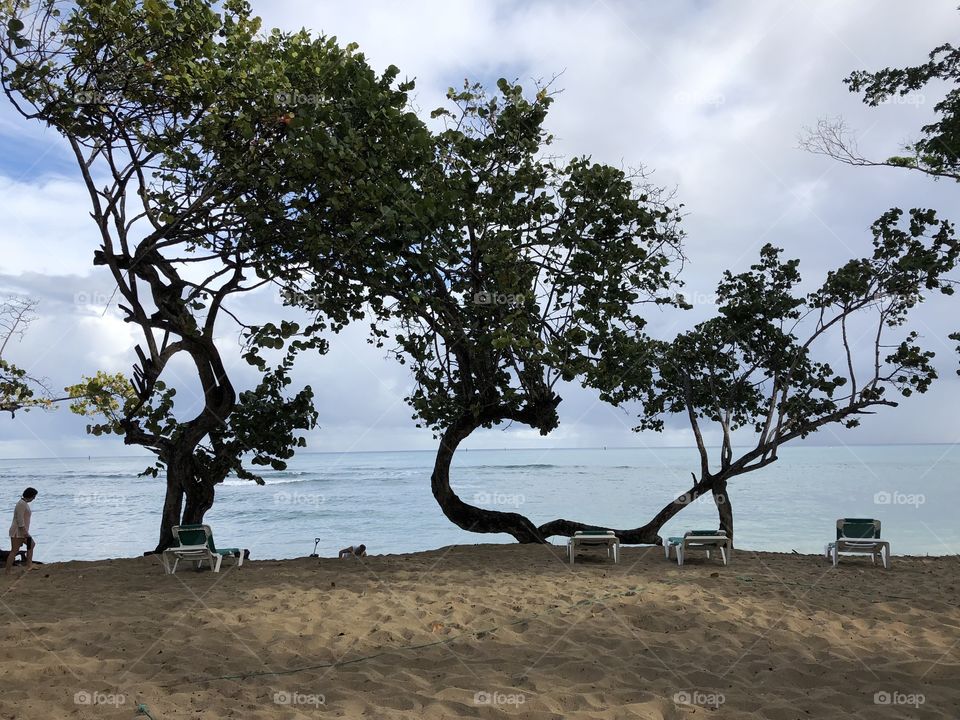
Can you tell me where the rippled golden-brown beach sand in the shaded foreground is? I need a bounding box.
[0,545,960,720]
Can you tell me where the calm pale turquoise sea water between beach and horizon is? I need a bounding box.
[0,445,960,561]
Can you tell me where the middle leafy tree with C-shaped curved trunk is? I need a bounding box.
[274,80,680,542]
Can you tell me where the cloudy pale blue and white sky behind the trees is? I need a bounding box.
[0,0,960,458]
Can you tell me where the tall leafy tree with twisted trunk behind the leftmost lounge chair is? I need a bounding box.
[0,0,428,550]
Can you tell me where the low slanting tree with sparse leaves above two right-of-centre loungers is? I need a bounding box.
[567,210,960,542]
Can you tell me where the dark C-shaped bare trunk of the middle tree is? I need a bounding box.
[430,419,546,543]
